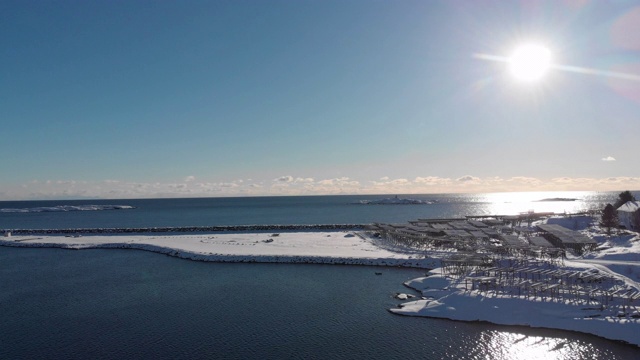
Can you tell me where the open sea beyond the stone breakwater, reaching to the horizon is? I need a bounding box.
[0,192,617,229]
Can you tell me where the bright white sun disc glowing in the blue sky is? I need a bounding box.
[508,44,551,82]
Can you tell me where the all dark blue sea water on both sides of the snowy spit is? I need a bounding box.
[0,193,640,359]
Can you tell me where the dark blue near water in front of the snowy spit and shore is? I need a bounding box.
[0,247,640,359]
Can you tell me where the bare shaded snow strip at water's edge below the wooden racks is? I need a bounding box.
[389,270,640,346]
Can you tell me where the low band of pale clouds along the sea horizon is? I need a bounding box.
[0,175,640,200]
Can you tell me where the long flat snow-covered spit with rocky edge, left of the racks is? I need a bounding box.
[0,232,433,268]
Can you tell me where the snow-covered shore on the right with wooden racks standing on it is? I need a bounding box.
[390,217,640,346]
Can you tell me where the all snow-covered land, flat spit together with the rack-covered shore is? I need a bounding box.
[0,217,640,346]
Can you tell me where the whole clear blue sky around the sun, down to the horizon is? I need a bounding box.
[0,0,640,200]
